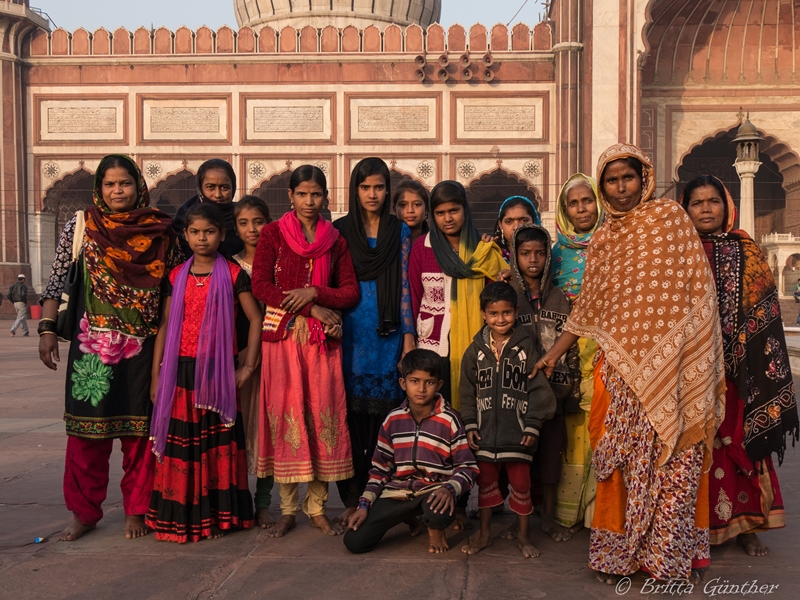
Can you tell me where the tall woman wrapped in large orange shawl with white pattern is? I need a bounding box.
[536,144,725,583]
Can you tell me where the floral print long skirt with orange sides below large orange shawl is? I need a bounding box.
[589,358,710,580]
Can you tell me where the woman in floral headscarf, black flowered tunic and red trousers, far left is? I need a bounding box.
[39,155,182,541]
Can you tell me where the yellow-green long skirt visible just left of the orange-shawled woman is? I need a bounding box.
[556,338,597,527]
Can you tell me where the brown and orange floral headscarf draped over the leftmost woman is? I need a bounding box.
[79,154,180,364]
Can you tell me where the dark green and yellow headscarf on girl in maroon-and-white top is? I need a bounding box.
[428,181,508,410]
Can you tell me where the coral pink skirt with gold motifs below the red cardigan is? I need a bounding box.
[257,335,354,483]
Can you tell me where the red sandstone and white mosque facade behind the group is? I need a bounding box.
[0,0,800,300]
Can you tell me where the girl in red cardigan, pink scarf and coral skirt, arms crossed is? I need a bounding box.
[253,165,359,537]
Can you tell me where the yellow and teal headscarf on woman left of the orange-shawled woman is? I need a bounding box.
[553,173,604,302]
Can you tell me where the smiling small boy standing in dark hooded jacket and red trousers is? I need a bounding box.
[460,281,556,558]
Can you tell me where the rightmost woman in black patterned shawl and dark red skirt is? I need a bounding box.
[681,175,798,556]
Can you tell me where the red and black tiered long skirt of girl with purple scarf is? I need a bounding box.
[146,359,254,543]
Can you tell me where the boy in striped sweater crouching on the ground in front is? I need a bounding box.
[344,350,478,554]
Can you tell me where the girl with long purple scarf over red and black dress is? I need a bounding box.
[146,204,261,543]
